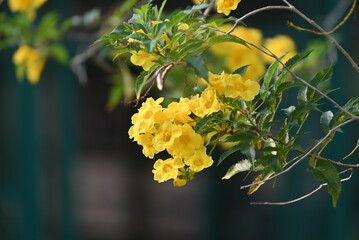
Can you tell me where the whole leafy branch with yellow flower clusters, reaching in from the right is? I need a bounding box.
[98,0,359,206]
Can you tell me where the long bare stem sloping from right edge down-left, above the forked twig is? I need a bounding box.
[240,118,354,189]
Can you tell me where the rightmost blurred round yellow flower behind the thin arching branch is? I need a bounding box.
[264,35,297,64]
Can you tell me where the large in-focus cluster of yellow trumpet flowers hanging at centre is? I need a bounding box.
[129,92,220,186]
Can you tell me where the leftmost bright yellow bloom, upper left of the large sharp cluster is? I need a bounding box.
[128,98,163,141]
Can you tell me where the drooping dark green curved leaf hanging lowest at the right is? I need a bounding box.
[309,160,342,207]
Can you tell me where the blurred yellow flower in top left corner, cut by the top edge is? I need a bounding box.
[8,0,47,20]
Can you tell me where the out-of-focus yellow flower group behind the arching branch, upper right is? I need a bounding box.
[211,24,296,81]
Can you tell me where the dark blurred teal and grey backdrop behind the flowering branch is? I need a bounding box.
[0,0,359,240]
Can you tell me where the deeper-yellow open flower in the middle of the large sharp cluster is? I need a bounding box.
[169,124,204,157]
